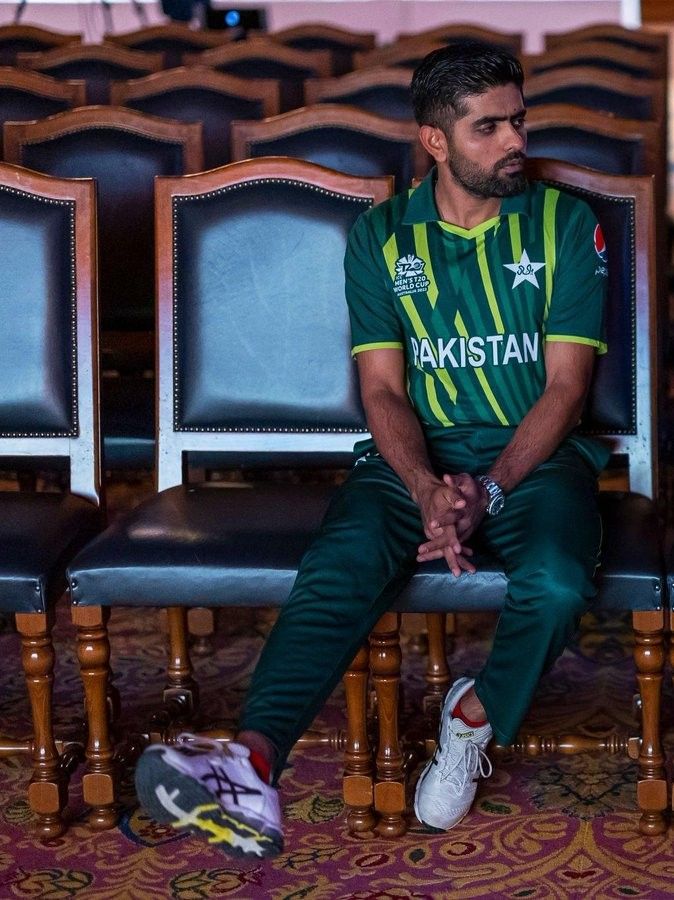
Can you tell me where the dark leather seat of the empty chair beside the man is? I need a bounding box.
[68,483,335,606]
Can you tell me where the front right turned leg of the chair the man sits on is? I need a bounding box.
[632,610,667,835]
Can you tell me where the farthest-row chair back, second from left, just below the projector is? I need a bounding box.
[103,22,240,69]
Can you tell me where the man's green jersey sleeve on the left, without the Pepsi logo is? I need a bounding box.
[344,213,404,355]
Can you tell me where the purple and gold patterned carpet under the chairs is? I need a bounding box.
[0,588,674,900]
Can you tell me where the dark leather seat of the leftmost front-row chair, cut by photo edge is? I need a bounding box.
[0,491,100,612]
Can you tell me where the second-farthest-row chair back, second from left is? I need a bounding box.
[183,38,332,112]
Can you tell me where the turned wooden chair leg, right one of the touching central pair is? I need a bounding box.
[370,613,407,837]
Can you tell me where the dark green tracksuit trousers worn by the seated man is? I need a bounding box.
[240,428,601,779]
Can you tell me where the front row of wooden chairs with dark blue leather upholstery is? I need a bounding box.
[0,158,668,836]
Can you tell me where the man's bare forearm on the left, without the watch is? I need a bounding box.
[366,390,439,503]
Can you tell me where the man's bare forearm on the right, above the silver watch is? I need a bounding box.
[489,384,584,493]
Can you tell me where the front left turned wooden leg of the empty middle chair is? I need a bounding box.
[72,606,118,830]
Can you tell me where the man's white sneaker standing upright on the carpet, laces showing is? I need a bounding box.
[414,678,492,831]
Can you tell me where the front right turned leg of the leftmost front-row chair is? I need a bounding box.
[16,612,68,838]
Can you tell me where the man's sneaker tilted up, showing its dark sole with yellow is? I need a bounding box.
[136,734,283,857]
